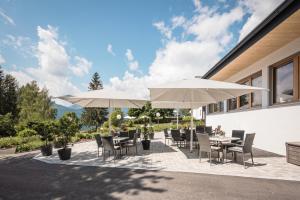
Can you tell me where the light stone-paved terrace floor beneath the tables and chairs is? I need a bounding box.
[34,133,300,181]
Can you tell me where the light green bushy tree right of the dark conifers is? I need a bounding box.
[18,81,56,122]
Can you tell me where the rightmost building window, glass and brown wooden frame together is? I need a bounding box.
[270,53,300,104]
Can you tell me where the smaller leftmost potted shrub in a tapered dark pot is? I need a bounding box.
[38,121,57,156]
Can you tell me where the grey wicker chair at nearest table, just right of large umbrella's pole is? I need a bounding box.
[197,133,221,164]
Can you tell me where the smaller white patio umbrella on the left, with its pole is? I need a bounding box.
[58,89,148,133]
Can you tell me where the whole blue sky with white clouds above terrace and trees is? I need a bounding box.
[0,0,283,105]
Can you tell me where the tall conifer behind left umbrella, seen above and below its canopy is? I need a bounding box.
[81,72,108,130]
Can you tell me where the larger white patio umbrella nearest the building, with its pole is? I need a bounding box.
[149,78,266,151]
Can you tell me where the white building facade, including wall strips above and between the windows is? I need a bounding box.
[206,38,300,155]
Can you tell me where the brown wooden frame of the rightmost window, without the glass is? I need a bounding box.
[269,52,300,106]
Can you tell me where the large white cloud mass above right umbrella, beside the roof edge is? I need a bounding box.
[106,1,244,97]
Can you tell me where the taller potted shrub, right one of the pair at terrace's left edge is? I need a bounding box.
[57,112,80,160]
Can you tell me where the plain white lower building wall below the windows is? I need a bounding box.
[206,105,300,155]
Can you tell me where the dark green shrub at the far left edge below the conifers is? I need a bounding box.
[0,113,16,137]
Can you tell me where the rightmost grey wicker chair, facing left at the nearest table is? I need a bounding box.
[228,133,255,168]
